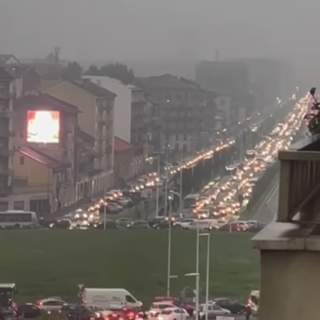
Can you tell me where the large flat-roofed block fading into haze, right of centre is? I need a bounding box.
[196,61,255,135]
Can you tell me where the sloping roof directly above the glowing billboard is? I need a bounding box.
[13,94,80,114]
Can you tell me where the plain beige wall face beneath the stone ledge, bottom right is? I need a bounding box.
[259,250,320,320]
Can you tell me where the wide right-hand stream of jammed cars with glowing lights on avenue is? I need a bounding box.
[174,95,307,232]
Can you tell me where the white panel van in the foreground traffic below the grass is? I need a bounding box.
[82,288,142,309]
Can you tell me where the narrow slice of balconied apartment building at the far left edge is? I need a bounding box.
[0,67,14,204]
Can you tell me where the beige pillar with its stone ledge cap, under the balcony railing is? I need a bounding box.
[252,222,320,320]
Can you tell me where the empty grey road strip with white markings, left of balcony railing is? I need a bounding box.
[252,181,279,225]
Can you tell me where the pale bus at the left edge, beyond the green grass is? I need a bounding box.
[0,210,39,228]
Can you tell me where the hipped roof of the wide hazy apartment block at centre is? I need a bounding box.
[137,74,200,90]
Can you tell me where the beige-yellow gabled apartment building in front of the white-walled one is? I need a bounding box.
[42,79,116,195]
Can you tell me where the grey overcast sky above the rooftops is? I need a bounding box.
[0,0,320,83]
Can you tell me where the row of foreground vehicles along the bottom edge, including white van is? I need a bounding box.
[0,283,255,320]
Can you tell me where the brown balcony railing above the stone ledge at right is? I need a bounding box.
[277,137,320,223]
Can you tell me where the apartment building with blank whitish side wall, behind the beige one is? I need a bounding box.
[83,76,152,175]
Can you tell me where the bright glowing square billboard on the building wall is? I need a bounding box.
[27,110,60,143]
